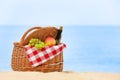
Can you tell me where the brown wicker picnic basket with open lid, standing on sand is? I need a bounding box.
[11,27,63,72]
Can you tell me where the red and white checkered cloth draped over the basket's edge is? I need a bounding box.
[24,43,66,67]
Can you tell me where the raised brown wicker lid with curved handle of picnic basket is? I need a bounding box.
[20,26,63,46]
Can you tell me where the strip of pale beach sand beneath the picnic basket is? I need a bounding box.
[0,71,120,80]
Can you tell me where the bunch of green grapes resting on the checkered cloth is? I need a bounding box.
[28,38,47,49]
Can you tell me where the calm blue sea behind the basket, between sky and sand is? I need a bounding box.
[0,25,120,73]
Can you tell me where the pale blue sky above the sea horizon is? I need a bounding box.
[0,0,120,26]
